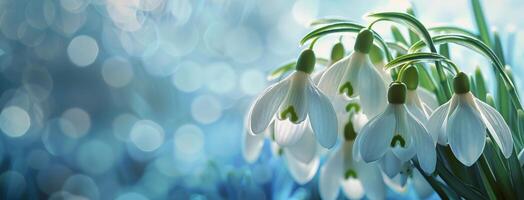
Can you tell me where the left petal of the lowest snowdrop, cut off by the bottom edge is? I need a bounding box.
[318,148,344,200]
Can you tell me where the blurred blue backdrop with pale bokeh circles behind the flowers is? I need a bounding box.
[0,0,524,200]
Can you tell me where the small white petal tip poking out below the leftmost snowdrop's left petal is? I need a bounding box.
[242,132,264,163]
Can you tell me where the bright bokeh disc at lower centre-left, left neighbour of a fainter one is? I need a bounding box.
[129,120,164,152]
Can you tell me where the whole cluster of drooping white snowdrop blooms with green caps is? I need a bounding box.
[239,7,524,199]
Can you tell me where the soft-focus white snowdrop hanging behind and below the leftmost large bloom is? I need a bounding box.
[242,120,320,184]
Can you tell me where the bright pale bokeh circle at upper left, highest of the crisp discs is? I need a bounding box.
[67,35,99,67]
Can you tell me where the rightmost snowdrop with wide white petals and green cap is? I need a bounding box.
[427,72,513,166]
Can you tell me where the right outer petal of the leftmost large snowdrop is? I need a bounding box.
[308,85,338,149]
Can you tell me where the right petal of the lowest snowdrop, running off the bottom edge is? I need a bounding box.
[355,162,386,199]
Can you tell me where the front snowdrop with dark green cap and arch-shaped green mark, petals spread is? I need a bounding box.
[353,82,436,177]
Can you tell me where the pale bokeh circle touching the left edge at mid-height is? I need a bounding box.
[0,106,31,137]
